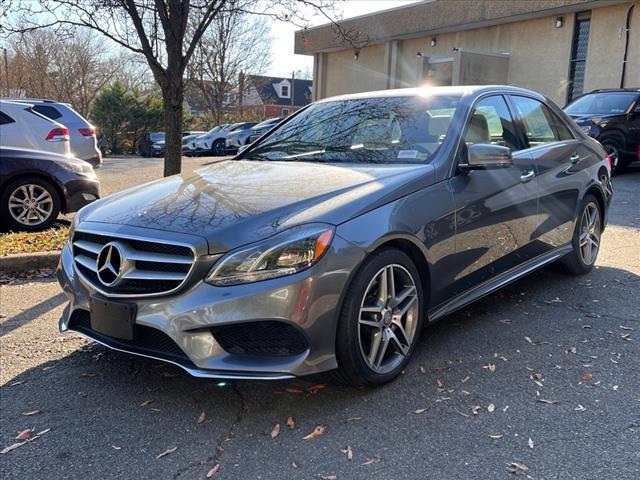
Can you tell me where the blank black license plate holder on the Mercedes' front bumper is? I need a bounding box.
[89,297,136,340]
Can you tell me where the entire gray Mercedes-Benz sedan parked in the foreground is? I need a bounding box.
[58,86,612,385]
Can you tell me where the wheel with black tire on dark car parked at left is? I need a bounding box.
[0,178,60,232]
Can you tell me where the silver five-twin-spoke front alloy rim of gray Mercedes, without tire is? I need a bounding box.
[358,264,419,374]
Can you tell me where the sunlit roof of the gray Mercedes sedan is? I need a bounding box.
[318,85,542,102]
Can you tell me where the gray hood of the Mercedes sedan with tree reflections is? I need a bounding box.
[79,160,435,253]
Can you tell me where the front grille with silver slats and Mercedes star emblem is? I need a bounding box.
[73,230,195,296]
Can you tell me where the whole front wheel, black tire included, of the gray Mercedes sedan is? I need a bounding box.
[336,249,424,387]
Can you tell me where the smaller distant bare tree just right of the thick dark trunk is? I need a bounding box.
[188,7,271,123]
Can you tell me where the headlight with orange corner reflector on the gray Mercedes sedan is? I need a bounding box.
[205,224,334,287]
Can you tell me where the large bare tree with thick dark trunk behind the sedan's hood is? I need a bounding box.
[2,0,350,175]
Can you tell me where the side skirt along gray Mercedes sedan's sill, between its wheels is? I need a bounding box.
[428,244,573,322]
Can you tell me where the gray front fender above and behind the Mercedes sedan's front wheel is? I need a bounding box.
[337,181,456,304]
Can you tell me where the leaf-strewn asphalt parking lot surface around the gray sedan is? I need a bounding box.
[0,162,640,479]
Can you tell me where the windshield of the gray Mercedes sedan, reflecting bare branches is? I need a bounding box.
[247,95,460,163]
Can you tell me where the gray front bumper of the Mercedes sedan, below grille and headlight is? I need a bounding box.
[57,231,364,379]
